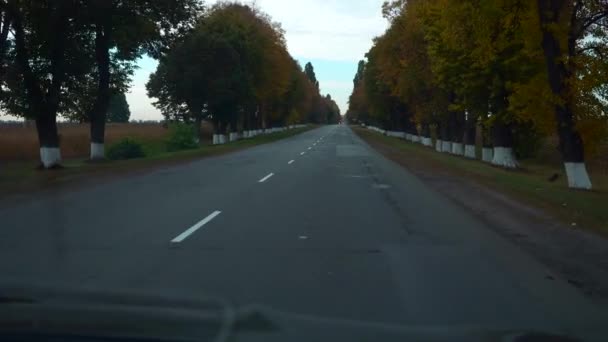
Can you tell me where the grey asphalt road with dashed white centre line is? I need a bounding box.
[0,126,608,336]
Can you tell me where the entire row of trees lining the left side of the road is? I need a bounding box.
[0,0,339,168]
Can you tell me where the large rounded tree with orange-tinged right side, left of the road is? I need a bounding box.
[147,3,310,141]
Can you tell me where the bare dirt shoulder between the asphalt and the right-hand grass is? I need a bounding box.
[354,128,608,304]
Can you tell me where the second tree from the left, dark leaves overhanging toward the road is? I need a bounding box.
[84,0,201,159]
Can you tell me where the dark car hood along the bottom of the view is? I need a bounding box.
[0,287,576,342]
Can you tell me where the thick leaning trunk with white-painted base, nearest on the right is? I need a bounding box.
[538,0,592,190]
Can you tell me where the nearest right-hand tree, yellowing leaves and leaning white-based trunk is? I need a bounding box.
[537,0,608,189]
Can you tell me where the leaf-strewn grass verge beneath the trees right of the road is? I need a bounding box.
[353,127,608,237]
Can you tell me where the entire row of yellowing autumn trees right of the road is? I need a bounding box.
[347,0,608,188]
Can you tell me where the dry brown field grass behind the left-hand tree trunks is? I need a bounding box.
[0,123,210,161]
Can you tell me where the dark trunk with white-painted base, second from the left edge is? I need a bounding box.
[91,23,111,160]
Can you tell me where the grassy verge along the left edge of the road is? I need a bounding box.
[0,126,315,197]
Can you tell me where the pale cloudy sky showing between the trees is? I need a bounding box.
[127,0,388,120]
